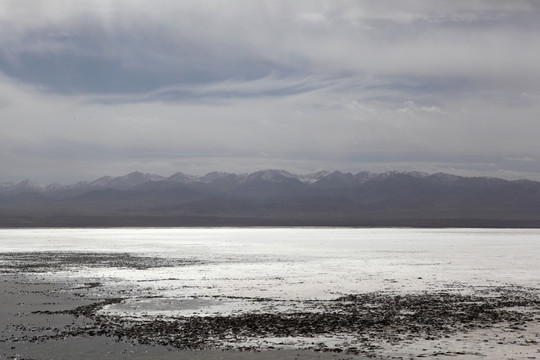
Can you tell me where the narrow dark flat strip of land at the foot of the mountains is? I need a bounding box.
[0,209,540,228]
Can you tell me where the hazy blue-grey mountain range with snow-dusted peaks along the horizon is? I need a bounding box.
[0,170,540,227]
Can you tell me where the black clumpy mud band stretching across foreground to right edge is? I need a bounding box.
[26,287,540,355]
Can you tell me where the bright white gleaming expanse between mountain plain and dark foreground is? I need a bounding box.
[0,228,540,299]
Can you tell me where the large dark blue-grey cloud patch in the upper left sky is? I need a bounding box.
[0,21,282,94]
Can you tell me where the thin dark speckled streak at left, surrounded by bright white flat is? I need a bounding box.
[0,251,203,273]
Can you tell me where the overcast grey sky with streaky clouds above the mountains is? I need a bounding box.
[0,0,540,183]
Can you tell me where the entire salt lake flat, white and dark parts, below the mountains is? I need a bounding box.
[0,228,540,359]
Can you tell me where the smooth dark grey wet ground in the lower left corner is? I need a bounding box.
[0,275,360,360]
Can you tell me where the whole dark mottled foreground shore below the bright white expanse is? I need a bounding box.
[0,253,540,360]
